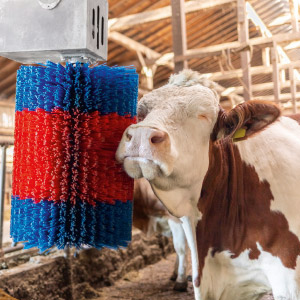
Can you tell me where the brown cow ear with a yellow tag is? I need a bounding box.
[217,100,281,142]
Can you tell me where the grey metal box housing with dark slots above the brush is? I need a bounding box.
[0,0,108,64]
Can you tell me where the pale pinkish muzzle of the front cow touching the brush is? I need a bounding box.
[116,125,174,180]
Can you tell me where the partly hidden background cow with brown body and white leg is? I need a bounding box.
[133,178,188,292]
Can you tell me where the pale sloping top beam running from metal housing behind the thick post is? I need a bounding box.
[108,0,235,31]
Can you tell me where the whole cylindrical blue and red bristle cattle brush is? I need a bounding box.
[11,62,138,251]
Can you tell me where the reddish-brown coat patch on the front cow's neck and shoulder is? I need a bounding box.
[197,140,300,282]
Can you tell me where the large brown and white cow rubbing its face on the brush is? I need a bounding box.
[116,70,300,300]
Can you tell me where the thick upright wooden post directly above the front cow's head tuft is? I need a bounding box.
[171,0,188,72]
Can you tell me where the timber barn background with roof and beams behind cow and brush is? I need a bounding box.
[0,0,300,298]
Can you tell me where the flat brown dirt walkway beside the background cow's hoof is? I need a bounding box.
[93,254,194,300]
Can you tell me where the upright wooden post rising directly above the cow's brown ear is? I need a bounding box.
[237,0,252,101]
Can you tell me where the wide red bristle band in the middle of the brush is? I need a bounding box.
[13,109,135,204]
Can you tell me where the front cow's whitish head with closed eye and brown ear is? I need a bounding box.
[116,70,280,217]
